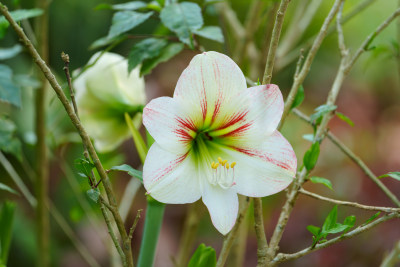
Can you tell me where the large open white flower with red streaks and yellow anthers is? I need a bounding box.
[143,52,297,235]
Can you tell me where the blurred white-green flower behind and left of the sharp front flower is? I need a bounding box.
[74,53,146,152]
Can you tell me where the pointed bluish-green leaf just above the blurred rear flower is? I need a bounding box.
[107,11,153,39]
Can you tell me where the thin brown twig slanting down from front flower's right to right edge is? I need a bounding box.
[292,109,400,207]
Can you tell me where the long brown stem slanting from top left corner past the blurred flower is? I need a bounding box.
[0,2,133,266]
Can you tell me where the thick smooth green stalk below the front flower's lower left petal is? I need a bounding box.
[137,196,165,267]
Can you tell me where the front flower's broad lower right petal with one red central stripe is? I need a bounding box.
[211,131,297,197]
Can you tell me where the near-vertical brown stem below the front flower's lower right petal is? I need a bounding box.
[254,198,268,266]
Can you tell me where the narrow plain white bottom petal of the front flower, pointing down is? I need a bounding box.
[202,181,239,235]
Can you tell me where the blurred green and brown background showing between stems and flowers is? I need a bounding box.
[0,0,400,267]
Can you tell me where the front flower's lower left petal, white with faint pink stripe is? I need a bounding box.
[143,143,201,204]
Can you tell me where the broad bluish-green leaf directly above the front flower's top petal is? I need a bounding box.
[160,2,203,48]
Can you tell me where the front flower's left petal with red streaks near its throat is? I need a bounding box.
[143,97,202,154]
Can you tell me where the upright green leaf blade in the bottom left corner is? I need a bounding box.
[0,201,15,265]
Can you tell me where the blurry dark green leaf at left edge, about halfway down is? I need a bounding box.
[0,117,22,161]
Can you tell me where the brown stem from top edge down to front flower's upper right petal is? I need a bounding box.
[262,0,290,84]
